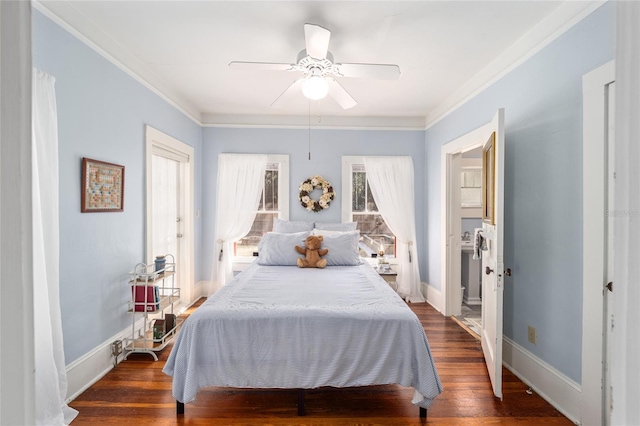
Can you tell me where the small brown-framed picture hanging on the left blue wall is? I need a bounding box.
[80,158,124,213]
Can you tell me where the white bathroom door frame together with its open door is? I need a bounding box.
[441,108,504,399]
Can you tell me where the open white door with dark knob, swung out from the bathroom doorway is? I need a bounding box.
[480,109,505,399]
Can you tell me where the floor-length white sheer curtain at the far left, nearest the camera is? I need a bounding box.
[32,70,78,425]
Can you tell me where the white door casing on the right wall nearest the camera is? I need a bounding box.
[580,61,615,425]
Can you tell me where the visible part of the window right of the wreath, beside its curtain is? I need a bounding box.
[342,157,396,257]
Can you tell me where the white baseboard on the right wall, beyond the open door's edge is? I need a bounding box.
[502,337,582,424]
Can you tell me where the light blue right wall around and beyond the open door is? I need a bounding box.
[426,2,614,382]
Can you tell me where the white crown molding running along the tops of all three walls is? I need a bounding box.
[32,0,608,130]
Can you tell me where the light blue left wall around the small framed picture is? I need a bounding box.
[33,10,202,363]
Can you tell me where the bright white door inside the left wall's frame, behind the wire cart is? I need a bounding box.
[151,155,182,287]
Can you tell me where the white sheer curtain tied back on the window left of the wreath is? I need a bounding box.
[209,154,267,293]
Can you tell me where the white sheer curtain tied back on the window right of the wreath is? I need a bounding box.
[364,157,425,302]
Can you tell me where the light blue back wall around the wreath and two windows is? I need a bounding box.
[200,128,426,282]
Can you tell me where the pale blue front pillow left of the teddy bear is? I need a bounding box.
[257,232,309,266]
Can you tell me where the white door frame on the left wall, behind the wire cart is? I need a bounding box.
[145,125,195,305]
